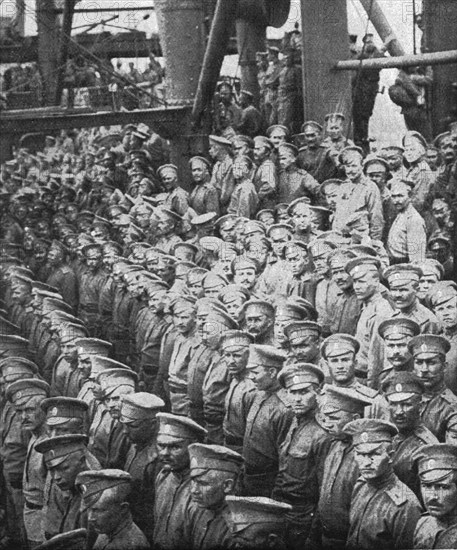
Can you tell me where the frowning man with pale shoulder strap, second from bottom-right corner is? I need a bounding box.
[344,419,421,550]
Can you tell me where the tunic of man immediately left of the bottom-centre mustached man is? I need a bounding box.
[154,469,190,550]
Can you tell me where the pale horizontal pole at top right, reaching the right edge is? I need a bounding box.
[334,50,457,71]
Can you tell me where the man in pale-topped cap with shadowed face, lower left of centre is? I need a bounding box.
[119,392,165,545]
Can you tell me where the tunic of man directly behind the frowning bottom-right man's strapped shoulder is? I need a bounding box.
[392,424,438,502]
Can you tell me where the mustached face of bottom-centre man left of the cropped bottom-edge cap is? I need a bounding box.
[190,470,234,509]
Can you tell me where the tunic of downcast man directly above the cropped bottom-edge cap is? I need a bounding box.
[243,388,293,497]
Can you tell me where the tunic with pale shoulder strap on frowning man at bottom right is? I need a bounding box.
[346,473,421,550]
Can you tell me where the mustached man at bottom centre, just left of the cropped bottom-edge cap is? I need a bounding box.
[183,443,243,550]
